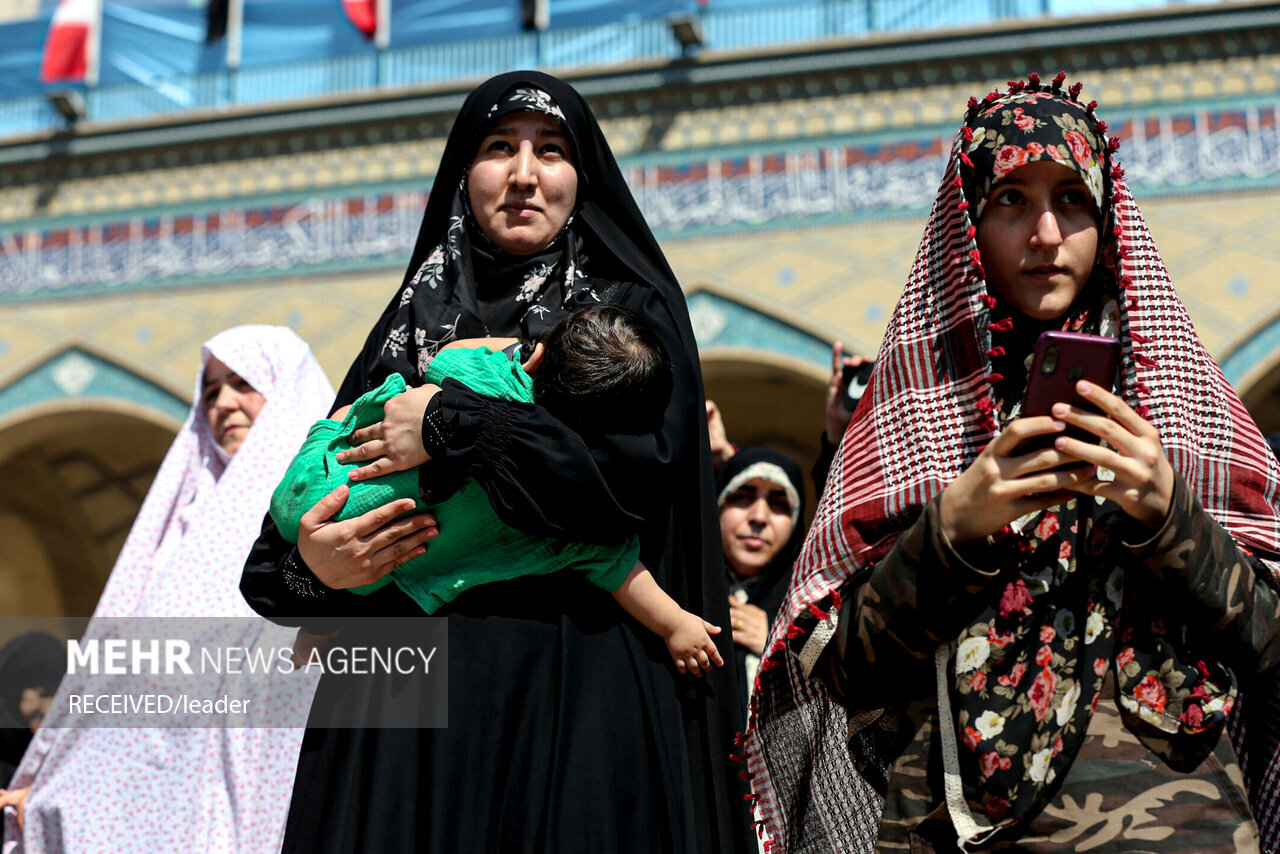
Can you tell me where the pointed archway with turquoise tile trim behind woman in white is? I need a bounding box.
[0,346,189,616]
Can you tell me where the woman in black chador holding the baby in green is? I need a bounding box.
[242,72,755,854]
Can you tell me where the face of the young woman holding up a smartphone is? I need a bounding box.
[978,160,1098,320]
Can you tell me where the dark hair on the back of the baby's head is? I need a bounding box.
[534,303,672,433]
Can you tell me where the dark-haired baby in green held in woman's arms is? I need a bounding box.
[271,303,723,676]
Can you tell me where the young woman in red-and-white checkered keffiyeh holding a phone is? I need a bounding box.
[744,74,1280,851]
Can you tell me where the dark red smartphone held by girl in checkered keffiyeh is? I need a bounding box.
[1020,332,1120,452]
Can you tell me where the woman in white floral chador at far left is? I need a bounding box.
[5,325,333,854]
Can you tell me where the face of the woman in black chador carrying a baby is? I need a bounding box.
[467,113,577,255]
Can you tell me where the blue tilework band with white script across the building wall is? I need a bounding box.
[0,105,1280,302]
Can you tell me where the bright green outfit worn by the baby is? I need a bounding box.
[271,347,640,613]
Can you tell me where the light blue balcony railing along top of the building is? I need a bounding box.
[0,0,1223,137]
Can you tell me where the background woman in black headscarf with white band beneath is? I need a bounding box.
[716,448,804,712]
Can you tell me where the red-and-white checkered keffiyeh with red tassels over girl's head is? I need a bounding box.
[742,74,1280,854]
